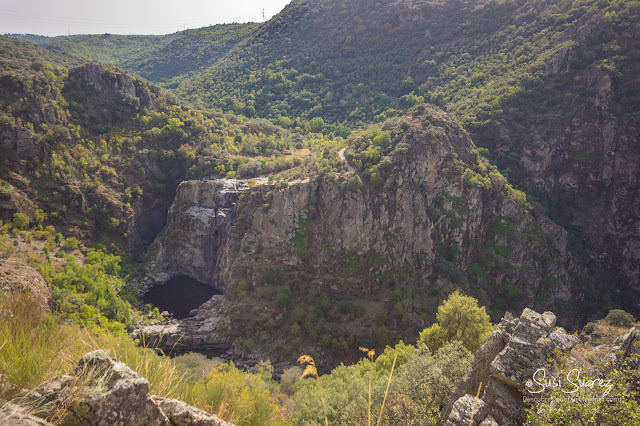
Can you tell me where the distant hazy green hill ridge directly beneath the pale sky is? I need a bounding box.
[11,23,258,87]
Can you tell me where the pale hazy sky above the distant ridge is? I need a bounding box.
[0,0,290,36]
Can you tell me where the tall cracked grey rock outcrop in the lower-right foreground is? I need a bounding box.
[443,308,578,426]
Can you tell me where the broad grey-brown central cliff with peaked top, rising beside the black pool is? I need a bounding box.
[145,109,582,362]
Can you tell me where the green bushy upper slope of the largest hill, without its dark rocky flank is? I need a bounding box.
[180,0,637,122]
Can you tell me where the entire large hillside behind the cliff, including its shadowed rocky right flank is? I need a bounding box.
[179,0,640,311]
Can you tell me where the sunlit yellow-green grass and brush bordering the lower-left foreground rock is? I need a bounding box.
[0,293,281,426]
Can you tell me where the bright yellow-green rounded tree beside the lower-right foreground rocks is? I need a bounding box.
[418,290,493,352]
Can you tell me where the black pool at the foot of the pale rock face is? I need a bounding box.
[142,275,222,319]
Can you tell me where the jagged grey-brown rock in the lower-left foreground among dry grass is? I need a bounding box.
[31,350,232,426]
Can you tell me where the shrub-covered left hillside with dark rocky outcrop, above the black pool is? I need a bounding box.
[0,37,342,257]
